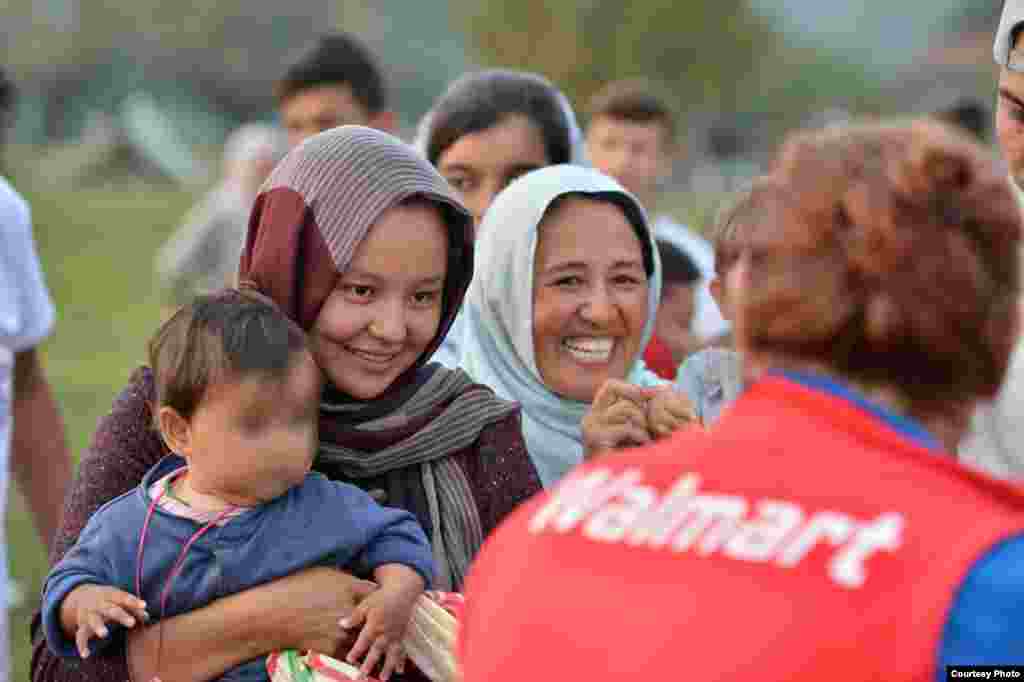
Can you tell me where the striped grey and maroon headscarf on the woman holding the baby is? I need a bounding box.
[239,126,516,589]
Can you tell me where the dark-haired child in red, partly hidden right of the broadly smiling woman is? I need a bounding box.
[643,240,700,381]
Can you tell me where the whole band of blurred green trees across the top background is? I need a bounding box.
[0,0,999,163]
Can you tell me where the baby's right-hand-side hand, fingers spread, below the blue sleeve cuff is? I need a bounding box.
[341,563,426,682]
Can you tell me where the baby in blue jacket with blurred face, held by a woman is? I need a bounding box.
[43,291,433,680]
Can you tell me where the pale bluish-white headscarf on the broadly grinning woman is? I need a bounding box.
[460,164,662,486]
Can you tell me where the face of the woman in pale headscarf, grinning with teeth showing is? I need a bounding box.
[534,197,649,402]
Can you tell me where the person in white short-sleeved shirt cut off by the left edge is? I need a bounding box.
[0,70,71,682]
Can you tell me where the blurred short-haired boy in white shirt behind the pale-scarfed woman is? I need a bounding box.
[587,80,729,343]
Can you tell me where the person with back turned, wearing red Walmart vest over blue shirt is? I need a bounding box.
[459,122,1024,682]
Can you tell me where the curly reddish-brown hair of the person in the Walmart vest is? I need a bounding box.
[740,121,1021,415]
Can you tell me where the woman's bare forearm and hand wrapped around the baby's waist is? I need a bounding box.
[127,567,377,682]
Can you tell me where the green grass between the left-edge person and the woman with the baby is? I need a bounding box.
[7,183,194,680]
